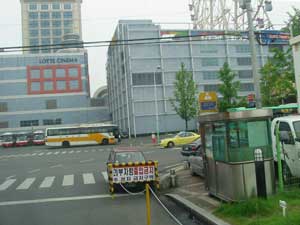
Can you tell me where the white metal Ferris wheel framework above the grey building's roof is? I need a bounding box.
[189,0,273,30]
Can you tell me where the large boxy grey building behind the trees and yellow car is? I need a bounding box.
[106,20,289,135]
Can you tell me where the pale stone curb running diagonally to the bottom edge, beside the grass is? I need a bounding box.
[165,194,230,225]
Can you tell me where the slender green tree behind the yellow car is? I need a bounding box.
[171,63,197,130]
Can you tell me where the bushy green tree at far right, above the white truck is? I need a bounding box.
[260,48,296,106]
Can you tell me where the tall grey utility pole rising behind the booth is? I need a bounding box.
[239,0,270,109]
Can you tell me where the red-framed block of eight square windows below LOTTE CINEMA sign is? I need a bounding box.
[27,65,82,94]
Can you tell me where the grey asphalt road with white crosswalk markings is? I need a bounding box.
[0,146,183,225]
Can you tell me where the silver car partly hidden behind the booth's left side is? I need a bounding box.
[188,147,205,177]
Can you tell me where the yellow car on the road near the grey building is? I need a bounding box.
[160,131,200,148]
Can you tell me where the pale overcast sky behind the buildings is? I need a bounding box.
[0,0,300,94]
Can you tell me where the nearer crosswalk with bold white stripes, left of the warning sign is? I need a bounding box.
[0,171,107,194]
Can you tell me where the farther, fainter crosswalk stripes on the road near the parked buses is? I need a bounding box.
[0,148,111,160]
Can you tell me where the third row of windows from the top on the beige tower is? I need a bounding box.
[28,20,73,29]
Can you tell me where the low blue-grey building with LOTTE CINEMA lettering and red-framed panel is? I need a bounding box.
[0,51,111,133]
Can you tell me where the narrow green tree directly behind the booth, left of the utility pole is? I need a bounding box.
[219,62,241,112]
